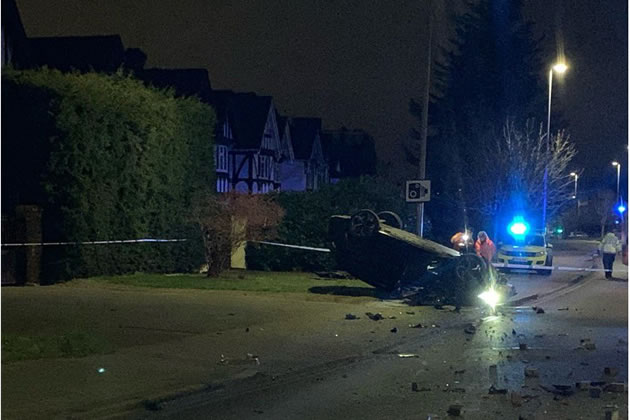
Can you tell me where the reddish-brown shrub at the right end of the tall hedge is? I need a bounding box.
[193,192,284,277]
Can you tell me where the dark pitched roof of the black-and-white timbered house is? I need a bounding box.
[210,90,272,149]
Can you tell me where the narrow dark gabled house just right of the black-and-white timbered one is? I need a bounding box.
[289,118,329,191]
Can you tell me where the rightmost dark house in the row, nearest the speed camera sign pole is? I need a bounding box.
[322,128,377,183]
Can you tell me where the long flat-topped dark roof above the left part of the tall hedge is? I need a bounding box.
[28,35,125,73]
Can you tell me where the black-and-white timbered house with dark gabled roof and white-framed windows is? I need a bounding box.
[212,90,280,193]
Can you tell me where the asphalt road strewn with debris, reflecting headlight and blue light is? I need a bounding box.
[147,274,628,419]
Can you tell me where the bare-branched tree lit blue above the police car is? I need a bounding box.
[465,119,576,225]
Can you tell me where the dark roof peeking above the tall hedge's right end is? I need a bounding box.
[136,68,212,103]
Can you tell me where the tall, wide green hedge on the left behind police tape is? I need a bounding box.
[2,68,215,281]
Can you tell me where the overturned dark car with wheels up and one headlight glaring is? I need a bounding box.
[328,210,509,307]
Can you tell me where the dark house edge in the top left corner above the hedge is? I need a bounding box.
[1,0,30,68]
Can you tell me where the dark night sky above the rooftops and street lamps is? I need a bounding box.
[17,0,628,195]
